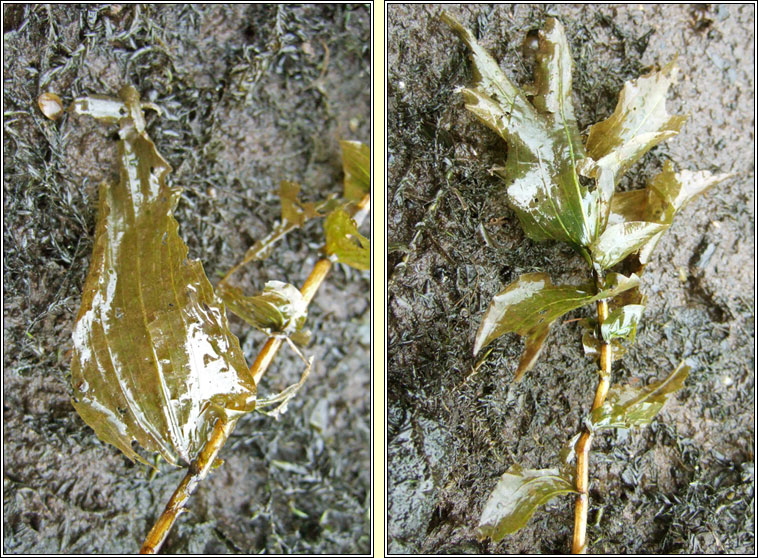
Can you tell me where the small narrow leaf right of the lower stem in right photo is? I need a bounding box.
[590,362,690,429]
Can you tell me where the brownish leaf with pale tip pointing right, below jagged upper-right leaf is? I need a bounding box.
[608,161,732,264]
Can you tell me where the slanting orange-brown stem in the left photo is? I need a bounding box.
[140,194,371,554]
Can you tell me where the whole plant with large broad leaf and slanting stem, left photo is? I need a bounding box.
[47,86,370,553]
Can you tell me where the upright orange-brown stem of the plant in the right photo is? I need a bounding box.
[571,300,613,554]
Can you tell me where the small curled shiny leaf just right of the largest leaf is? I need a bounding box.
[218,281,308,335]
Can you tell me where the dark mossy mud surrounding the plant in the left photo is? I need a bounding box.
[3,4,371,554]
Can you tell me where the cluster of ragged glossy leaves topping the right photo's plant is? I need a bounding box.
[441,13,729,271]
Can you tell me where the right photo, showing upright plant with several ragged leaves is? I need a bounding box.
[385,3,755,555]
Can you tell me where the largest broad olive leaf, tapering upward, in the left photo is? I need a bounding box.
[71,87,256,463]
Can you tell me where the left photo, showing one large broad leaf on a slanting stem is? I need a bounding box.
[3,2,372,556]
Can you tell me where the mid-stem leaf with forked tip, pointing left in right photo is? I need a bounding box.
[474,273,639,381]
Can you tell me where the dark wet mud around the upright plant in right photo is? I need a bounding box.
[387,4,755,554]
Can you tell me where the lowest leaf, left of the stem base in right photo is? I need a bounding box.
[478,465,576,542]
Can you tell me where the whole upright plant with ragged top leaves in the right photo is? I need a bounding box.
[442,14,729,553]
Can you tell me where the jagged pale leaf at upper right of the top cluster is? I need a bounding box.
[583,60,687,230]
